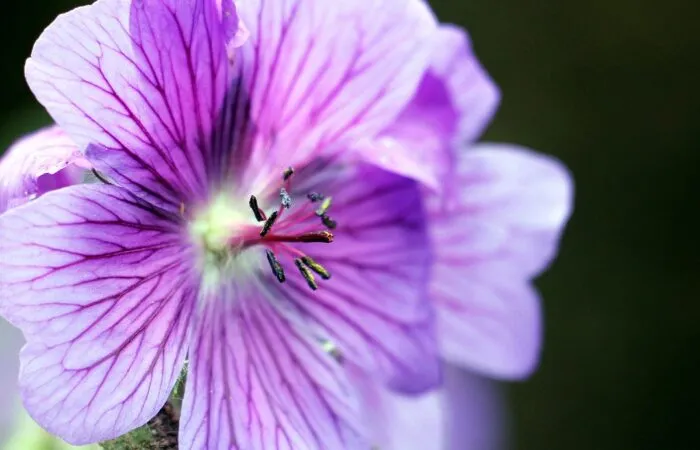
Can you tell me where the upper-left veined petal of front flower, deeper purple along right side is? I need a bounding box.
[26,0,228,209]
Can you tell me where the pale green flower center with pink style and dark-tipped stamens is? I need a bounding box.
[189,167,336,290]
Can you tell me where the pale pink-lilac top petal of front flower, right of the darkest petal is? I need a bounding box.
[233,0,436,190]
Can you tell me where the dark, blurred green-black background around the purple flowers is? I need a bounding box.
[0,0,700,450]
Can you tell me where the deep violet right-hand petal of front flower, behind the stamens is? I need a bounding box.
[266,166,440,393]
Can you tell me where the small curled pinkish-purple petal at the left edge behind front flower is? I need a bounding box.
[0,126,90,213]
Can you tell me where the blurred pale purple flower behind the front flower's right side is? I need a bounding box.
[352,26,573,450]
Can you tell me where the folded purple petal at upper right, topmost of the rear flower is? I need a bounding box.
[364,25,500,190]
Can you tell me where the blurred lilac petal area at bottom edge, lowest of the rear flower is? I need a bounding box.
[363,366,507,450]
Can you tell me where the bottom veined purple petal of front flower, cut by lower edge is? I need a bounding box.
[179,285,369,450]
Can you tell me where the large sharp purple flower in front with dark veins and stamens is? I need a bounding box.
[0,0,452,449]
